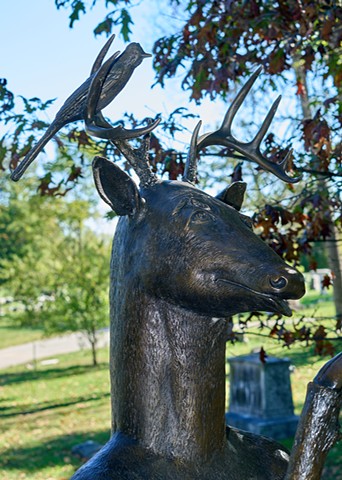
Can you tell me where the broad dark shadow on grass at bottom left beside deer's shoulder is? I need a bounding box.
[0,430,110,479]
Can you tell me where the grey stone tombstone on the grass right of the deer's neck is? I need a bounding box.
[226,354,298,439]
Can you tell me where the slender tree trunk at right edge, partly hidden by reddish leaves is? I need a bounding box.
[294,62,342,330]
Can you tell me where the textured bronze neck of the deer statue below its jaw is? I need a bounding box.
[111,290,226,462]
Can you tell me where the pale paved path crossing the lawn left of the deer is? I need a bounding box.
[0,329,109,369]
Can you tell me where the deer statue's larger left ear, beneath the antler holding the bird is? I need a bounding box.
[93,157,142,215]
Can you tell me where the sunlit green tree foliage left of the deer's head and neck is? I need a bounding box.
[0,177,110,365]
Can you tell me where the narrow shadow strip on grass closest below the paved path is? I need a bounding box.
[0,363,108,386]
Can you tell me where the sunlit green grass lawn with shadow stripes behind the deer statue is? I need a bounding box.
[0,337,342,480]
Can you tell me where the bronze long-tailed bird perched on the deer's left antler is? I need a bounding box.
[11,35,159,181]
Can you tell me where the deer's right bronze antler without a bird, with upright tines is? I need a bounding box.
[183,68,300,183]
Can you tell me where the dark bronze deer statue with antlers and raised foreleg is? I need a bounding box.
[10,38,342,480]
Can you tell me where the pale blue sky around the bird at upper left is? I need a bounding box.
[0,0,240,148]
